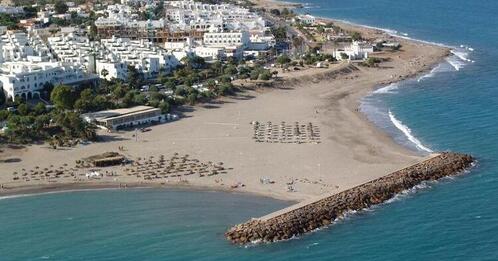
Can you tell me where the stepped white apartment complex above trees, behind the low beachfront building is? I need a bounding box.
[48,34,180,80]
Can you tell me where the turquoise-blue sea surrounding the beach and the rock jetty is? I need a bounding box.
[0,0,498,260]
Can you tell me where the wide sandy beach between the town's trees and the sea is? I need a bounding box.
[0,8,449,201]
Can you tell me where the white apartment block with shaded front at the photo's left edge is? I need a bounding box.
[0,62,97,100]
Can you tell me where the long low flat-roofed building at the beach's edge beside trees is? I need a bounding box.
[81,106,165,130]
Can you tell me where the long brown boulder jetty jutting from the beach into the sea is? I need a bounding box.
[225,152,474,244]
